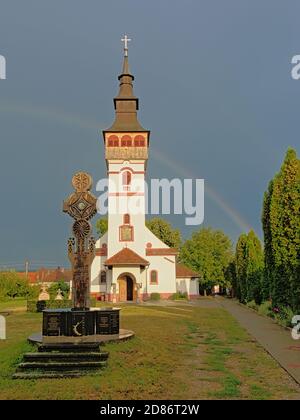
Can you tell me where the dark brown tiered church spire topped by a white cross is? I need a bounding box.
[106,35,146,132]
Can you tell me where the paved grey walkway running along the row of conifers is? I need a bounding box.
[215,297,300,384]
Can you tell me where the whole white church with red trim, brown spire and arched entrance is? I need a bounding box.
[91,36,199,302]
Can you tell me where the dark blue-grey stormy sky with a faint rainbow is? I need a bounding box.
[0,0,300,268]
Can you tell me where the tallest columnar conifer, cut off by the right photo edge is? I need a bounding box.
[267,149,300,311]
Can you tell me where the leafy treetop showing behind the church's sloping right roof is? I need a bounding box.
[146,217,181,248]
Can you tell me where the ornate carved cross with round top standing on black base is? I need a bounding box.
[63,172,97,310]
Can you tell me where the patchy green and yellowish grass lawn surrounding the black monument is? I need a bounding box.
[0,302,300,399]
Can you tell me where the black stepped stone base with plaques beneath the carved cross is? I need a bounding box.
[13,308,134,379]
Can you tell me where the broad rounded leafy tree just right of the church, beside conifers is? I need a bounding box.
[180,228,232,291]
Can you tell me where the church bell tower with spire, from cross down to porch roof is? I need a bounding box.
[103,35,150,256]
